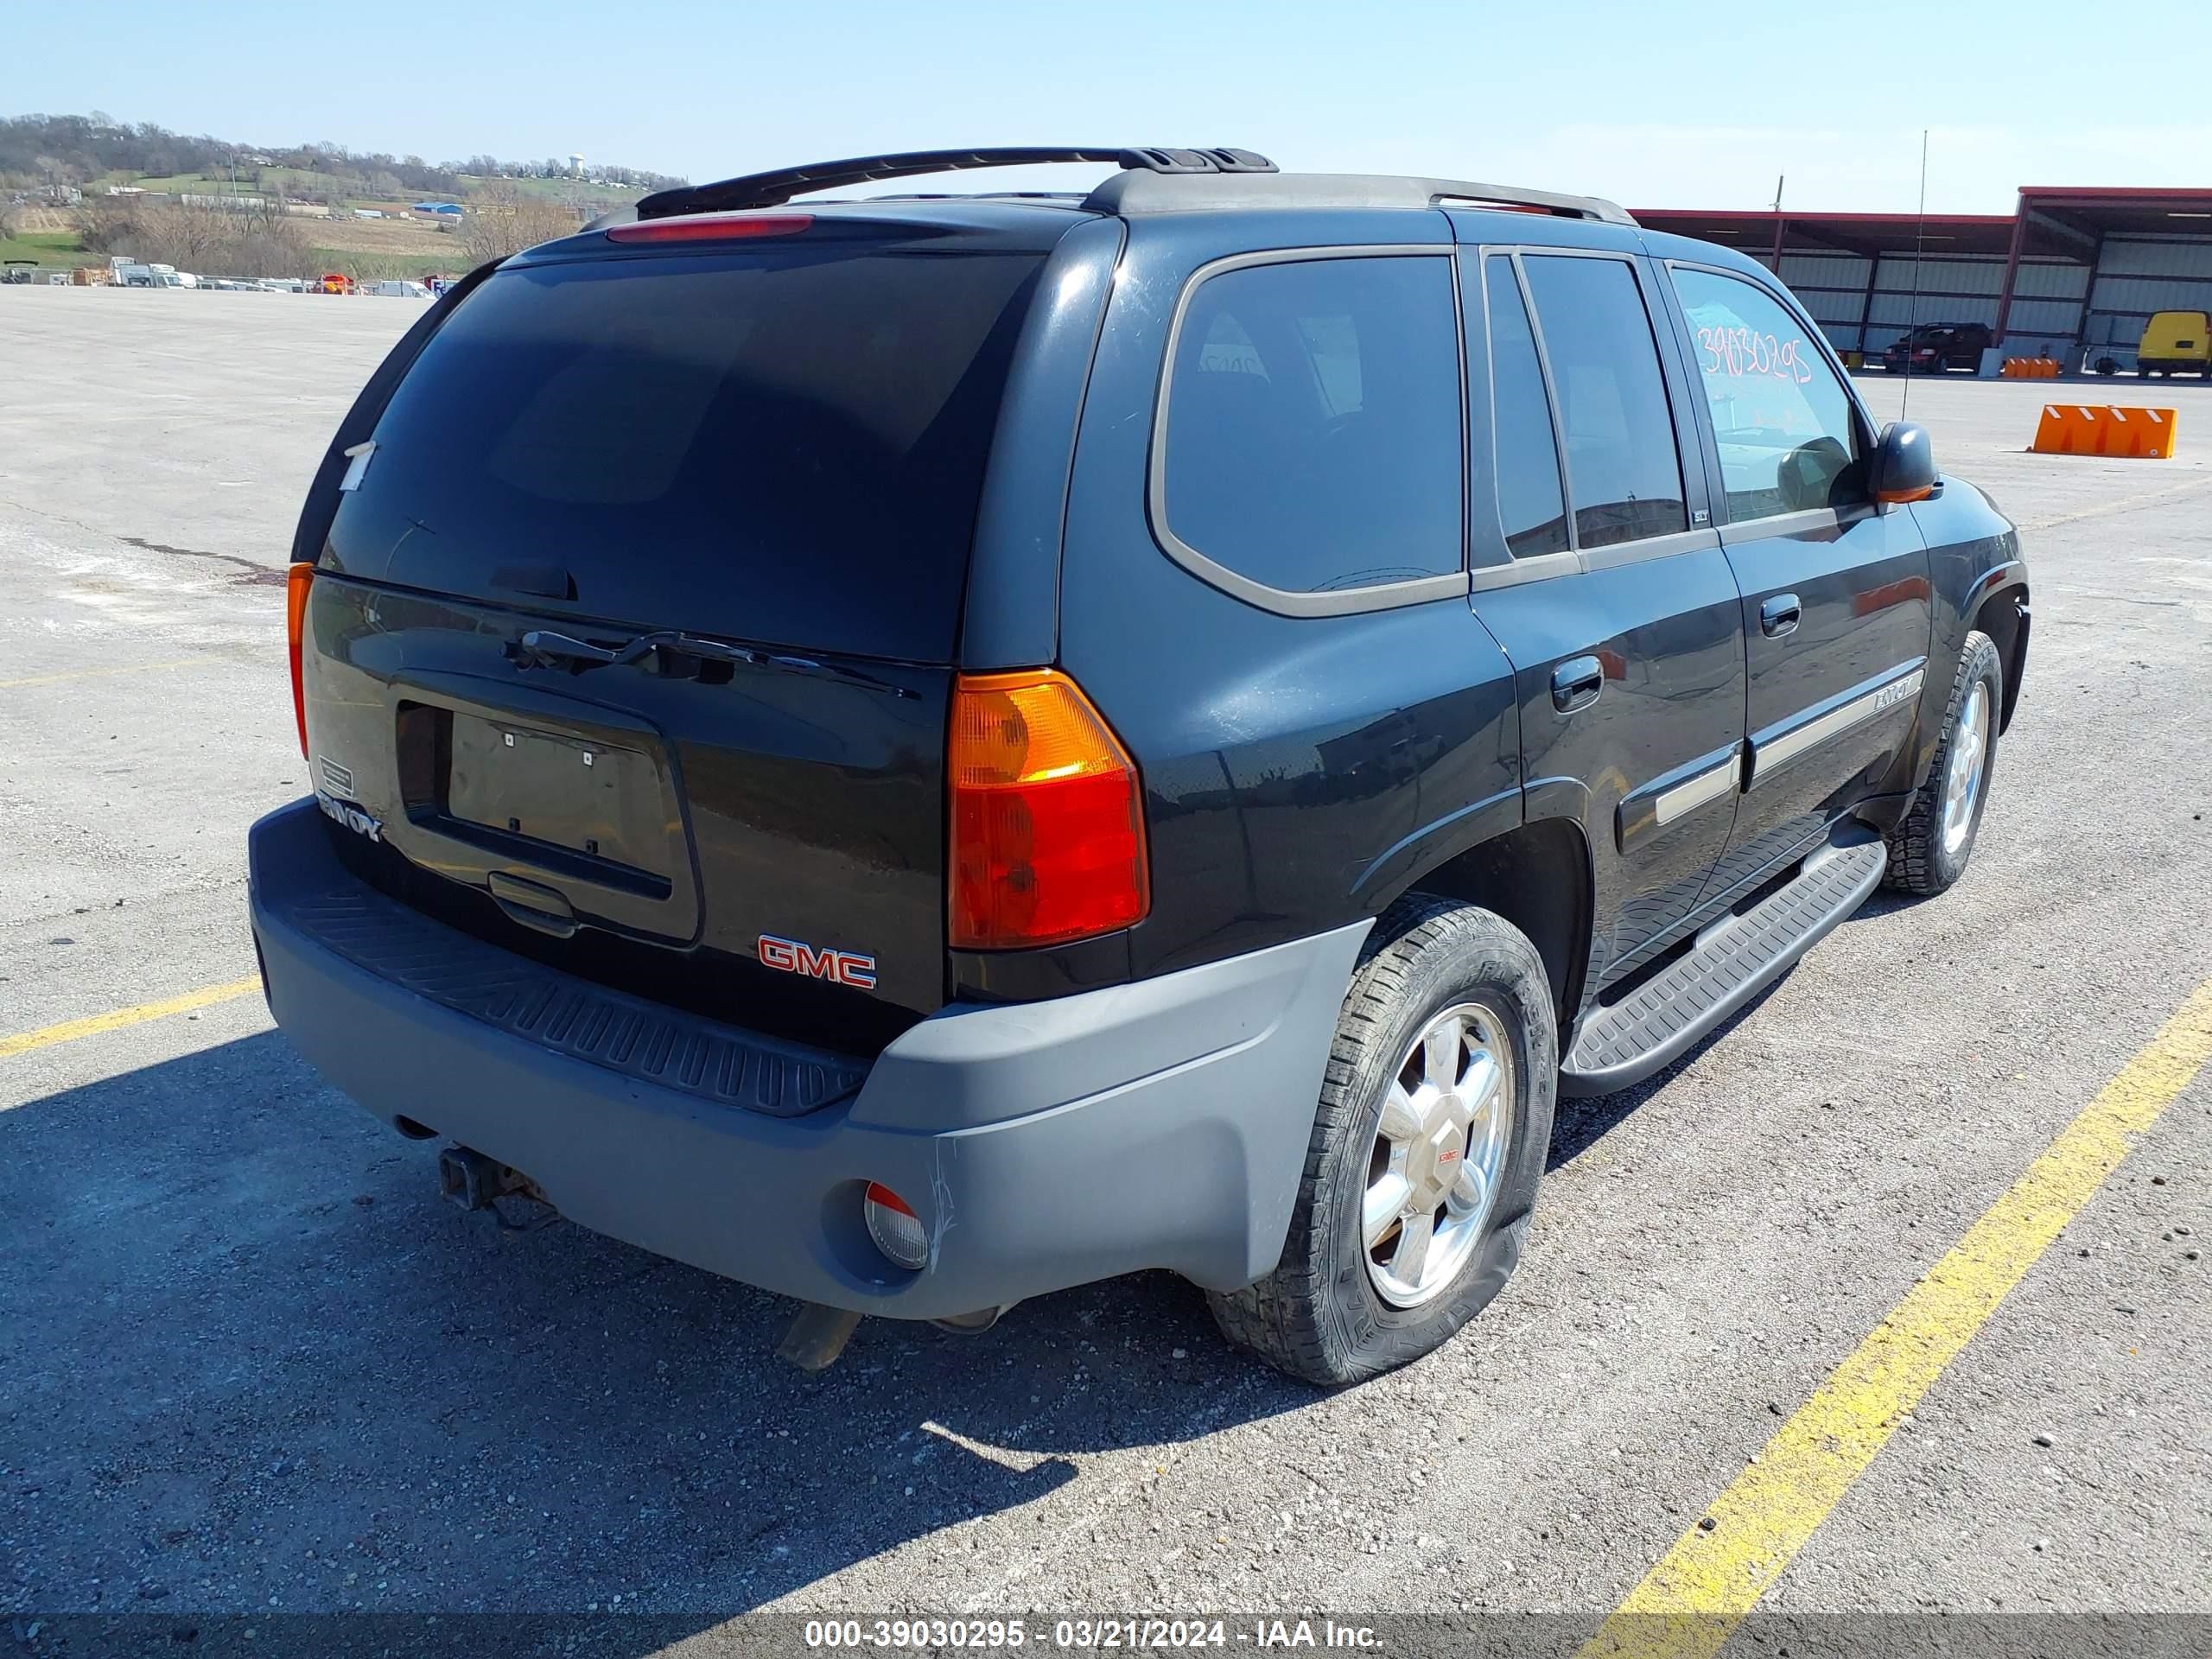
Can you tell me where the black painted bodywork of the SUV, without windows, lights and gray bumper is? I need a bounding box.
[285,204,2026,1051]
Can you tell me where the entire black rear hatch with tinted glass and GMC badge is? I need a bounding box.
[303,217,1044,1053]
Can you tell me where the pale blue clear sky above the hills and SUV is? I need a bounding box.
[0,0,2212,213]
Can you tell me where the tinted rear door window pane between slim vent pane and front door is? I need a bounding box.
[1522,254,1690,546]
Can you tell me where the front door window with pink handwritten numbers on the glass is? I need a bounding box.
[1675,270,1858,524]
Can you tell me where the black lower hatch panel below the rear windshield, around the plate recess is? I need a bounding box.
[305,573,951,1051]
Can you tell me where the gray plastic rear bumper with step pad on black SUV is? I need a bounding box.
[250,801,1367,1319]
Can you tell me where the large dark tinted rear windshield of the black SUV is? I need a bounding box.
[329,244,1044,661]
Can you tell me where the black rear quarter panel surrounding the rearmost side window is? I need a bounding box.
[1059,213,1522,978]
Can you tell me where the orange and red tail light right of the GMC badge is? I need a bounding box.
[947,668,1153,951]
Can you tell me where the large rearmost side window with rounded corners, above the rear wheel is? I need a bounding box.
[1157,257,1462,593]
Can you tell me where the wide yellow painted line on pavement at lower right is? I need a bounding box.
[1581,980,2212,1659]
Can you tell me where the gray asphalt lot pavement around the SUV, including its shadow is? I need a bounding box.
[0,288,2212,1652]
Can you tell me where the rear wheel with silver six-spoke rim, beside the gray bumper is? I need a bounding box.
[1208,893,1560,1387]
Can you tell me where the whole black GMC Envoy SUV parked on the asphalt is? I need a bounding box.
[250,149,2029,1382]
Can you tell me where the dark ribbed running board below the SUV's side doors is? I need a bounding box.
[1560,832,1889,1099]
